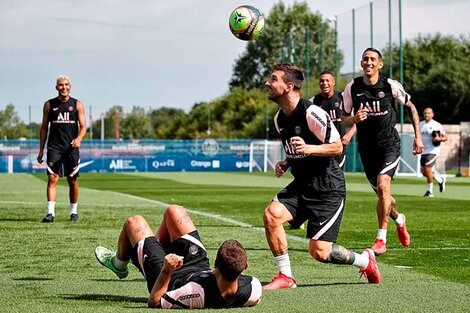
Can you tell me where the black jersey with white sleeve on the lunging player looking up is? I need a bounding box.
[274,99,345,193]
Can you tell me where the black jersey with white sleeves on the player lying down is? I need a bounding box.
[160,270,262,309]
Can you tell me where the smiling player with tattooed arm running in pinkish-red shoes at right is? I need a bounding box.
[342,48,423,255]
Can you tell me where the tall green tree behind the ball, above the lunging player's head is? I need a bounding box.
[230,2,342,97]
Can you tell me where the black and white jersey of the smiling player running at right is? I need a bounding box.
[343,76,410,152]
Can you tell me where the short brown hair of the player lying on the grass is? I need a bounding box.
[215,239,247,281]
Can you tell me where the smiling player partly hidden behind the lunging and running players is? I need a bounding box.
[310,71,356,168]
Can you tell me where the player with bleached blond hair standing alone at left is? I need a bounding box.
[37,75,86,223]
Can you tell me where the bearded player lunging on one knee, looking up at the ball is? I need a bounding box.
[263,64,380,289]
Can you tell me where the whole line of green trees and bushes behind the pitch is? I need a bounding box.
[0,2,470,139]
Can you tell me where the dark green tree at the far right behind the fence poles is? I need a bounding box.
[383,34,470,123]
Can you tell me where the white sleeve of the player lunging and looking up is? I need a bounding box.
[306,105,340,143]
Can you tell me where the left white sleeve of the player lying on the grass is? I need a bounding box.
[160,282,205,309]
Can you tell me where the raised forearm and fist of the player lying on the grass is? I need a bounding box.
[147,253,183,308]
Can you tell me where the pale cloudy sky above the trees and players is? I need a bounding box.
[0,0,470,122]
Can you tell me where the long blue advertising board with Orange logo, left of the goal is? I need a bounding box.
[0,139,258,173]
